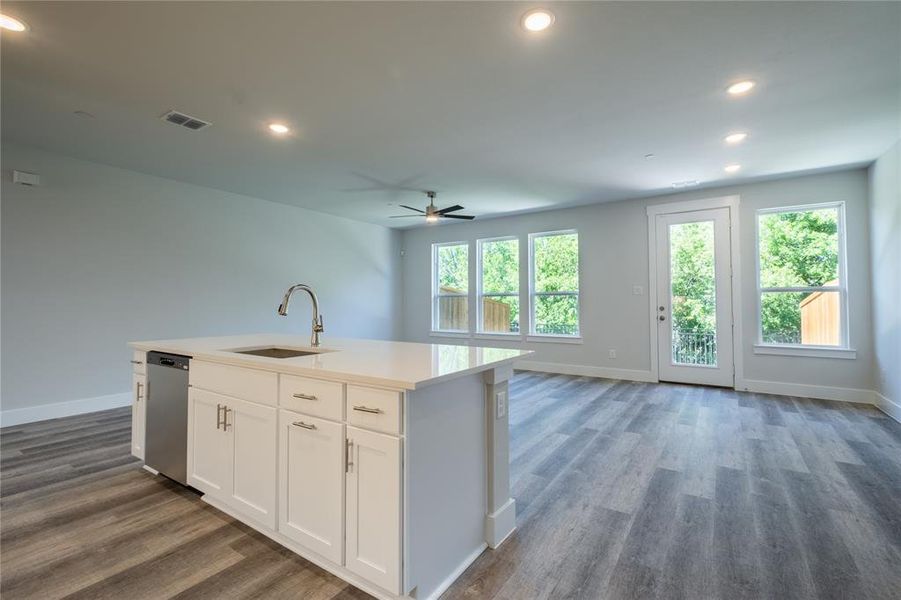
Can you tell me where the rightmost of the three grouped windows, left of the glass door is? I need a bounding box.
[529,231,579,337]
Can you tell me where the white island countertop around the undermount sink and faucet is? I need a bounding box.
[128,333,532,390]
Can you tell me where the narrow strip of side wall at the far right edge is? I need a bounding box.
[870,142,901,420]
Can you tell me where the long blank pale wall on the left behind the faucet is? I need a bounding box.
[0,144,401,424]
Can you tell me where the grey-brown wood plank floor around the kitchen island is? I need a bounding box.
[0,373,901,600]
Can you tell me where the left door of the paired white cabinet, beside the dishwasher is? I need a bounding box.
[188,388,232,500]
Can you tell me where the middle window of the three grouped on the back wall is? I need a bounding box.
[478,238,519,333]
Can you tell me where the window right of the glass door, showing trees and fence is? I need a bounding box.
[757,203,848,347]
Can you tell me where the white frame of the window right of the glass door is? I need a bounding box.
[754,201,857,359]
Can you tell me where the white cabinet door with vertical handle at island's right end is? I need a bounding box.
[345,426,401,594]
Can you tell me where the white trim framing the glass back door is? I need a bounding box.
[647,195,744,388]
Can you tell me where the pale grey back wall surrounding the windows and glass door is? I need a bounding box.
[403,169,872,399]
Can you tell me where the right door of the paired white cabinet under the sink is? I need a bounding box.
[224,398,278,530]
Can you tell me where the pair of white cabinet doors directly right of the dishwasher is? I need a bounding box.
[188,388,278,529]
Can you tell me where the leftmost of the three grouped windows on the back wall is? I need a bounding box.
[432,242,469,332]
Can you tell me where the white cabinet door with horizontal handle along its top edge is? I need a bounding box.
[279,410,344,565]
